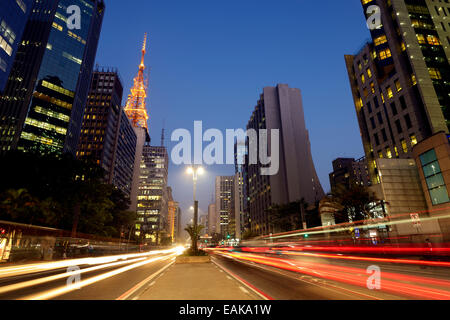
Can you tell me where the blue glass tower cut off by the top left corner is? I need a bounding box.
[0,0,33,92]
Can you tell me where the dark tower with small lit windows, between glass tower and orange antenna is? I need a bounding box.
[77,67,137,196]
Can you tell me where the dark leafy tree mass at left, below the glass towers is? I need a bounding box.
[0,151,136,237]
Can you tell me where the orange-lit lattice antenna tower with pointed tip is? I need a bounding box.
[125,34,148,130]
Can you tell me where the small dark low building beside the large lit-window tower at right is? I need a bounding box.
[330,158,371,191]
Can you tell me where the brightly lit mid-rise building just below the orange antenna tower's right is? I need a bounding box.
[136,144,169,244]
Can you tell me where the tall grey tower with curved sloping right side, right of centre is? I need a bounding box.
[244,84,324,234]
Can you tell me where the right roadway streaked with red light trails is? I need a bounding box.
[209,254,450,300]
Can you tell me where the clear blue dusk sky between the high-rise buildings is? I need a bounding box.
[97,0,370,222]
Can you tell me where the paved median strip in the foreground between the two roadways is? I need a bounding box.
[138,262,261,300]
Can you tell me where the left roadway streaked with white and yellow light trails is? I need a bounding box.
[0,253,179,300]
